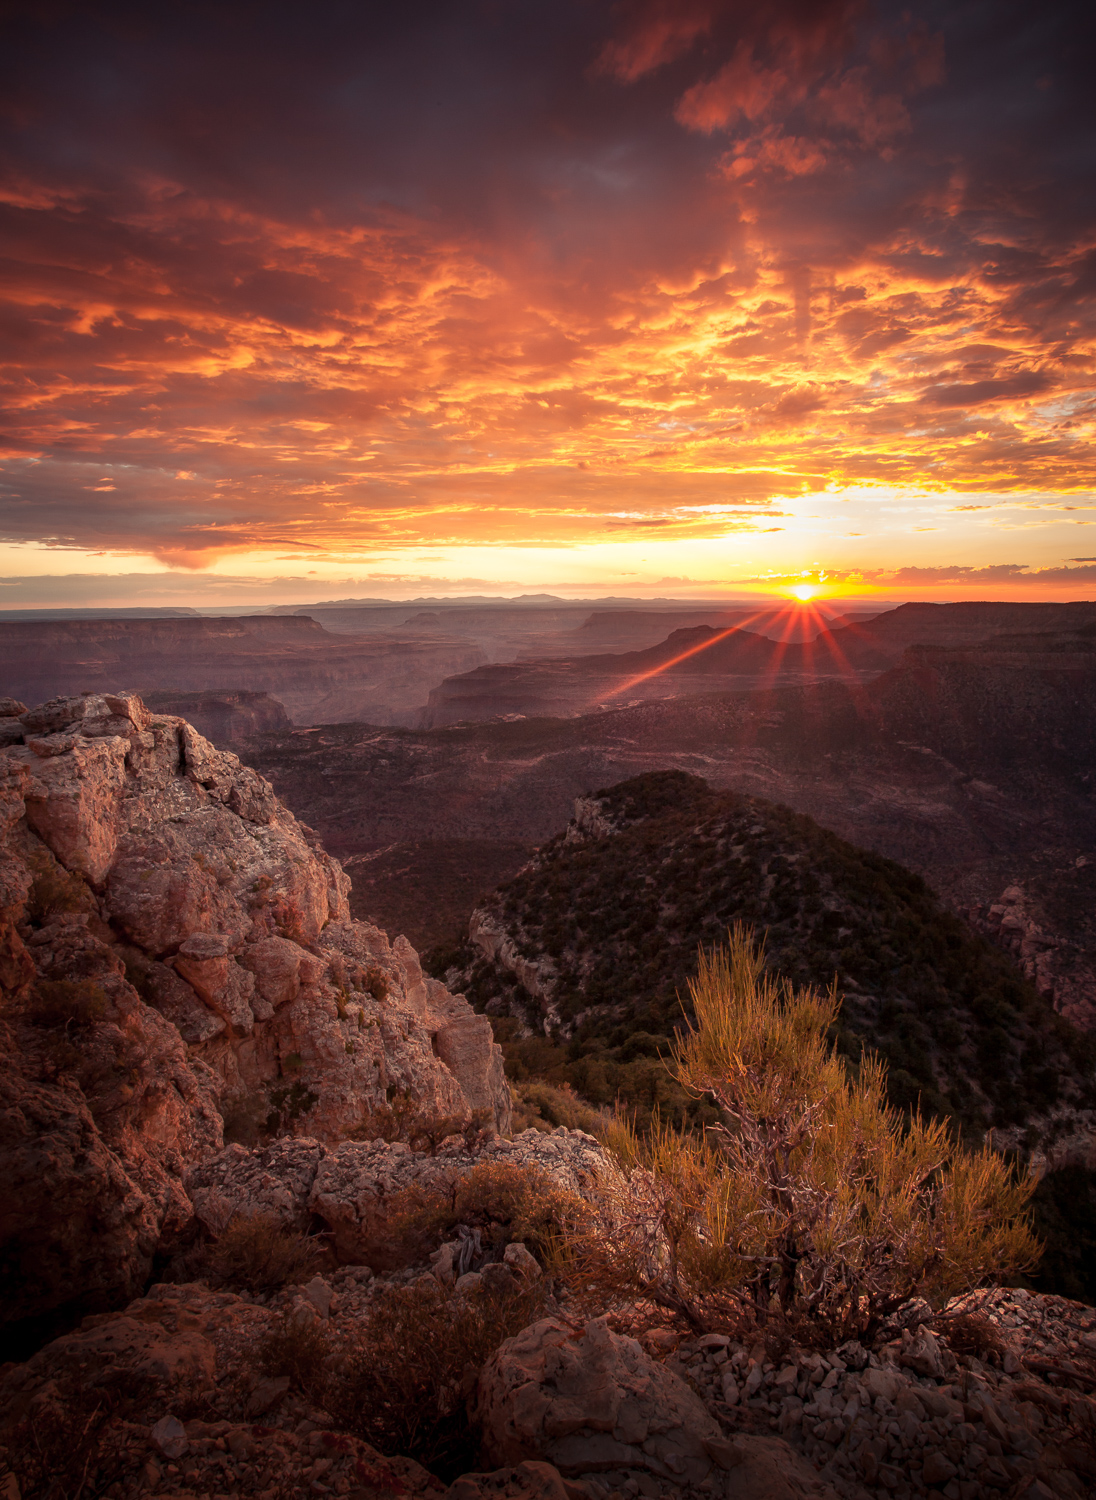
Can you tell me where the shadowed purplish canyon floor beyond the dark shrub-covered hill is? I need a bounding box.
[249,638,1096,1020]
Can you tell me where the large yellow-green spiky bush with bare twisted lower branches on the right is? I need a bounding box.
[576,927,1038,1338]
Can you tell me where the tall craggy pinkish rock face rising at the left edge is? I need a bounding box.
[0,693,510,1322]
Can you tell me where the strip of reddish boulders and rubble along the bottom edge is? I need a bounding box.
[0,1266,1096,1500]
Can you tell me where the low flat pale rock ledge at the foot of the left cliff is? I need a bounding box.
[187,1130,618,1271]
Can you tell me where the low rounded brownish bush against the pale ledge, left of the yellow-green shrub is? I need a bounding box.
[391,1161,589,1259]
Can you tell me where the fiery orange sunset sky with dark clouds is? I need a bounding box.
[0,0,1096,608]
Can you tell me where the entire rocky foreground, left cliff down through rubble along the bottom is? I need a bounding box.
[0,695,1096,1500]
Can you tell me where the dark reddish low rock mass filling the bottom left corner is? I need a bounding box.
[0,1286,446,1500]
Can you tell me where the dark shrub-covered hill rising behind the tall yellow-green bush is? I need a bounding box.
[447,771,1096,1139]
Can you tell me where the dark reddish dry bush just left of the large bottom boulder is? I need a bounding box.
[324,1278,549,1479]
